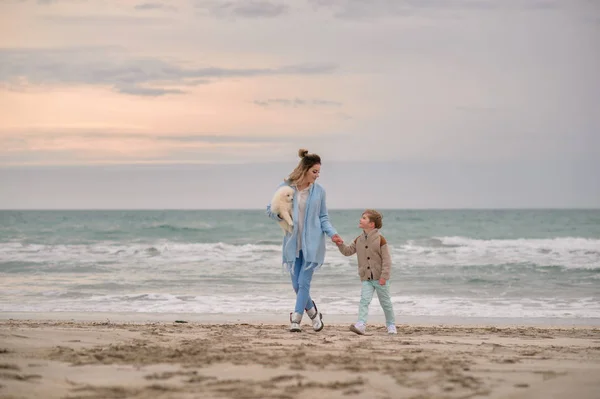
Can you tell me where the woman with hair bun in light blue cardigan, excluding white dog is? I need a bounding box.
[267,149,342,332]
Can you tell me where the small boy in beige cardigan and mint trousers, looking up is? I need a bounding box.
[337,209,397,335]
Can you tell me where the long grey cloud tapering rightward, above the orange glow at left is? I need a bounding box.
[0,47,337,96]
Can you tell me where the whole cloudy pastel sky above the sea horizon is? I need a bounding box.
[0,0,600,209]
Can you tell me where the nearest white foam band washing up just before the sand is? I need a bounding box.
[0,291,600,323]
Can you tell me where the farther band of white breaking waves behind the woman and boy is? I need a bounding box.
[0,237,600,273]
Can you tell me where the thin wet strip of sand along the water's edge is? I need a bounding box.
[0,311,600,328]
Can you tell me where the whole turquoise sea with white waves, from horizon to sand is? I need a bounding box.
[0,210,600,325]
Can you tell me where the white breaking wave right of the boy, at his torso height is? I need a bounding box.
[393,237,600,269]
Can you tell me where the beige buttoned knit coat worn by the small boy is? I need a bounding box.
[338,229,392,281]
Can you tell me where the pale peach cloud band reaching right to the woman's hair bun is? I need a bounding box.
[0,128,322,168]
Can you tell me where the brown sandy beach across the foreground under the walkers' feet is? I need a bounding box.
[0,320,600,399]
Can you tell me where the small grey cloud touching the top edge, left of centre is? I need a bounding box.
[196,0,289,18]
